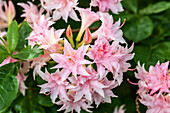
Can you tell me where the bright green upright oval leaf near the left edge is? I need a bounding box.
[7,20,19,52]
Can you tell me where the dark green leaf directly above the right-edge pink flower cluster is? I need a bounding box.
[134,42,170,68]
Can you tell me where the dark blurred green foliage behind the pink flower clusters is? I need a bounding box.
[6,0,170,113]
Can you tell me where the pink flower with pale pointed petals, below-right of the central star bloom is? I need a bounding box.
[69,65,114,102]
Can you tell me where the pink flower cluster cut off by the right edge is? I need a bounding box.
[135,62,170,113]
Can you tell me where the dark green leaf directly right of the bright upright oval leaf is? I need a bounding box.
[15,21,32,51]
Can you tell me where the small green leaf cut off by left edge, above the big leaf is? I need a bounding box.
[0,44,8,64]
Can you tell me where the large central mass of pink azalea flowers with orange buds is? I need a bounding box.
[0,0,131,112]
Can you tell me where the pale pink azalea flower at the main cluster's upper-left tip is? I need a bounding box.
[18,2,44,23]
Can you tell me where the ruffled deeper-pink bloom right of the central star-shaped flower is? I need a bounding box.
[88,36,134,85]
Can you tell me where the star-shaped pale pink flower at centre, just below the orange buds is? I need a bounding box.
[50,40,92,81]
